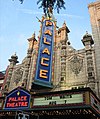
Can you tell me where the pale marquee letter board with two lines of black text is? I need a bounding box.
[33,94,84,107]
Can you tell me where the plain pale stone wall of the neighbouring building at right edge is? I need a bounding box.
[88,1,100,96]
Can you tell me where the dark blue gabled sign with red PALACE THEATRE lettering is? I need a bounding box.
[4,88,30,109]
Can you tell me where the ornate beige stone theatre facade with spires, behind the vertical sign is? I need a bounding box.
[2,0,100,96]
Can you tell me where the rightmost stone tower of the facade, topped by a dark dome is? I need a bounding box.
[82,32,96,91]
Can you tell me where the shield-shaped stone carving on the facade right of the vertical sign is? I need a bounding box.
[70,56,83,75]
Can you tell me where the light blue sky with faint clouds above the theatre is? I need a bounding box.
[0,0,96,71]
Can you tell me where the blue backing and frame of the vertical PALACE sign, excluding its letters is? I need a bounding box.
[33,20,54,88]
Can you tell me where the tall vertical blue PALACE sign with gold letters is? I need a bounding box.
[34,20,54,87]
